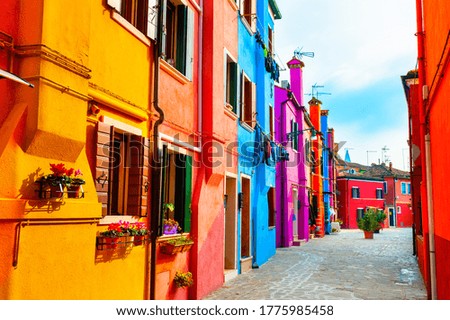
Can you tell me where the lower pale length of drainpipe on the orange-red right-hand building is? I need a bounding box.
[425,133,437,300]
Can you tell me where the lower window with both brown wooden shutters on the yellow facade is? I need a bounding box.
[95,122,149,216]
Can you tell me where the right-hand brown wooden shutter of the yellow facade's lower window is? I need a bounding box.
[127,135,149,216]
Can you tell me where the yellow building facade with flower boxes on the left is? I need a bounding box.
[0,0,154,299]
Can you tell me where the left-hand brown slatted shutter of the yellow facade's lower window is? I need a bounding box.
[94,122,114,216]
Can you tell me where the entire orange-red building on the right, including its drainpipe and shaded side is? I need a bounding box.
[402,0,450,299]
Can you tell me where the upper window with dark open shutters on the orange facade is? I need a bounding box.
[160,0,194,80]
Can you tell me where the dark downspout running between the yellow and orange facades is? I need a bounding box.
[149,0,164,300]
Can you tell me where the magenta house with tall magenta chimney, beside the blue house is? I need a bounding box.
[274,58,310,247]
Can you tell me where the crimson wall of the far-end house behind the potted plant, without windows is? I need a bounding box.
[337,178,384,229]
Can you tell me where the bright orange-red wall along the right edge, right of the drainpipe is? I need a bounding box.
[419,0,450,299]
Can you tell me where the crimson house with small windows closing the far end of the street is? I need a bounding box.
[337,173,385,229]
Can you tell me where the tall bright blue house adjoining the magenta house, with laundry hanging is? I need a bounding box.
[237,0,281,273]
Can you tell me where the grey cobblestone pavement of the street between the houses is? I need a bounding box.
[205,228,427,300]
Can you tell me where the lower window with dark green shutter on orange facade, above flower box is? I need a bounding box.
[162,146,192,232]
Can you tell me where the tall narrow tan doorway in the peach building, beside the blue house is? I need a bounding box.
[224,176,237,281]
